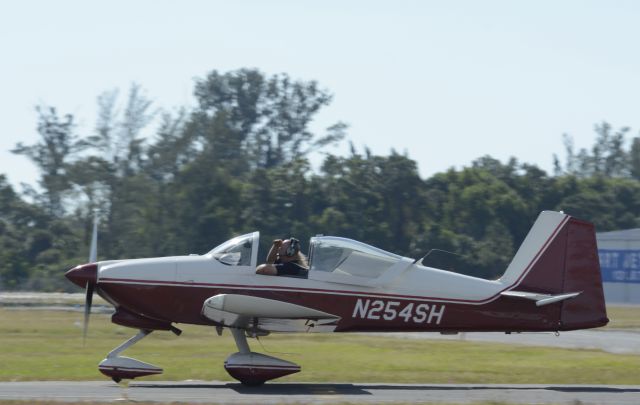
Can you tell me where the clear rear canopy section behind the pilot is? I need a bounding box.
[310,236,402,278]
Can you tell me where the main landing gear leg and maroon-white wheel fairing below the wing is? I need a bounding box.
[224,328,300,387]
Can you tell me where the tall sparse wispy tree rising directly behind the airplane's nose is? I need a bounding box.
[68,83,155,257]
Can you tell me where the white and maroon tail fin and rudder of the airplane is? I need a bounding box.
[499,211,609,330]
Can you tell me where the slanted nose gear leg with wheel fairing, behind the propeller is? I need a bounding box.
[98,329,162,383]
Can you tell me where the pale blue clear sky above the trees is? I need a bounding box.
[0,0,640,189]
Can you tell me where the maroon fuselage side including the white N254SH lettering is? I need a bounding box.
[98,274,595,332]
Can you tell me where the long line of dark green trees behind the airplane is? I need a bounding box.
[0,69,640,291]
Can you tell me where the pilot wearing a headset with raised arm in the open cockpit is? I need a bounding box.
[256,238,309,278]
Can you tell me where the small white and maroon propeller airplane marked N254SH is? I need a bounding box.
[65,211,609,386]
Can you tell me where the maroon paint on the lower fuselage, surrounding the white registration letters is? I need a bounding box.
[94,284,600,332]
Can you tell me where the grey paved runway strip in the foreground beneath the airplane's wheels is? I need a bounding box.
[0,381,640,405]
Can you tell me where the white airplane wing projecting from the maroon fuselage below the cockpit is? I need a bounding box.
[202,294,340,332]
